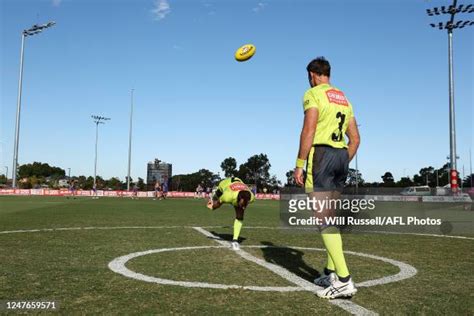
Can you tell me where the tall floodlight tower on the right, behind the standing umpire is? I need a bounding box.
[426,0,474,193]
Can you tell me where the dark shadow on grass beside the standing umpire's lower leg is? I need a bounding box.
[261,241,320,282]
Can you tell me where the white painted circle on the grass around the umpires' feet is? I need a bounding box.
[108,245,417,292]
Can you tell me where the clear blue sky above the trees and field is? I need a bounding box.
[0,0,474,181]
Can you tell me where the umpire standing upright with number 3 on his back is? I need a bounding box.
[294,57,360,299]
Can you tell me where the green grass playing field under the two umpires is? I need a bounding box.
[0,197,474,315]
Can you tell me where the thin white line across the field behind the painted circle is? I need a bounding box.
[0,226,474,240]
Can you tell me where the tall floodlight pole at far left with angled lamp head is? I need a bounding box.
[12,21,56,188]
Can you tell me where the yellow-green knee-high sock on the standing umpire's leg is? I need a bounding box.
[321,226,349,278]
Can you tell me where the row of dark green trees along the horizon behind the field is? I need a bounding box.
[0,160,473,193]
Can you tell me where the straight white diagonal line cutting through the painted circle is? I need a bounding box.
[194,227,377,315]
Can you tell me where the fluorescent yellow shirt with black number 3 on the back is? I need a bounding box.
[303,84,354,148]
